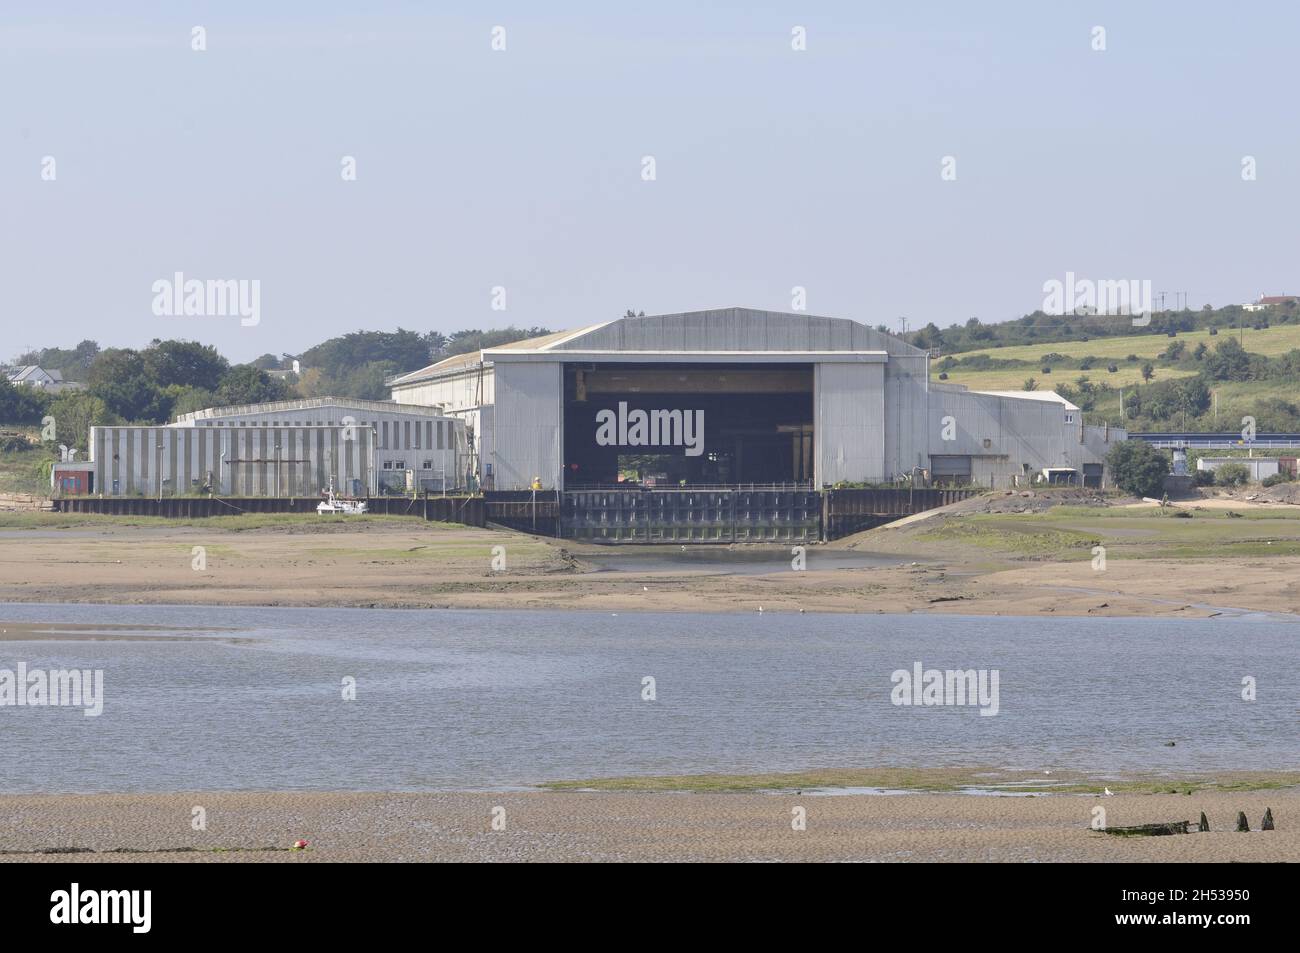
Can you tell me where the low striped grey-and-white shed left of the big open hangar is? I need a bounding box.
[90,397,468,497]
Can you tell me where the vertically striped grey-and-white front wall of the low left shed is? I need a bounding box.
[90,426,376,497]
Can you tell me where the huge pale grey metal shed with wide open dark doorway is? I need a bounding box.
[391,308,1125,490]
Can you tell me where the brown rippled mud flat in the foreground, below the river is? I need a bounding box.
[0,789,1300,863]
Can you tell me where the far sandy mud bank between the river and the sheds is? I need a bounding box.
[0,504,1300,618]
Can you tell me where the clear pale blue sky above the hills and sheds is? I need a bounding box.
[0,0,1300,360]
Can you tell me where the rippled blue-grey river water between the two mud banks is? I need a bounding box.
[0,605,1300,792]
